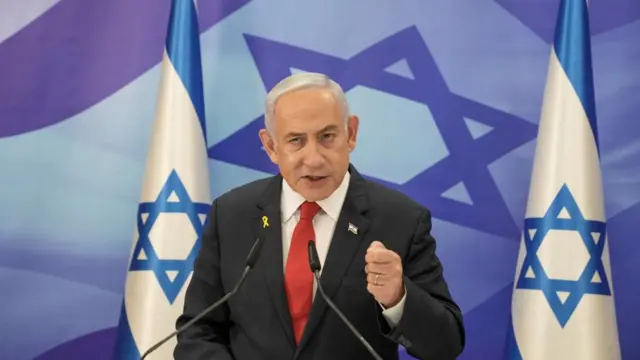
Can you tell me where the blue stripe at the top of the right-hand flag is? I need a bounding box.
[554,0,600,151]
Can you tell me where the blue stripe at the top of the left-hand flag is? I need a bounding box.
[166,0,207,138]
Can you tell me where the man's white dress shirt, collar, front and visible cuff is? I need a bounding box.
[280,171,406,327]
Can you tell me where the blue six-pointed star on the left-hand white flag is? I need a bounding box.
[129,170,211,304]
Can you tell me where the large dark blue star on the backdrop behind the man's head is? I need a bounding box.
[209,26,537,241]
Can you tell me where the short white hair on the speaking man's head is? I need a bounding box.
[264,72,349,134]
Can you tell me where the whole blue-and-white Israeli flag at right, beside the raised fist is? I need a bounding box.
[506,0,620,360]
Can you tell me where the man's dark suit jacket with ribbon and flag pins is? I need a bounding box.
[174,167,465,360]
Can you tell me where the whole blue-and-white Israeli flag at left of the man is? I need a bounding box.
[114,0,211,360]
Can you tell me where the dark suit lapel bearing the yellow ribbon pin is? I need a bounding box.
[255,175,295,347]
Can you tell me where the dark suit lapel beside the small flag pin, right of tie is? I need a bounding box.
[298,167,369,352]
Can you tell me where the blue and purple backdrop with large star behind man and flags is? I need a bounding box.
[0,0,640,360]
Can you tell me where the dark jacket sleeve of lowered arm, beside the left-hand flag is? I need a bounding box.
[174,201,233,360]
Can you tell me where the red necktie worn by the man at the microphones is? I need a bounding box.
[284,202,320,343]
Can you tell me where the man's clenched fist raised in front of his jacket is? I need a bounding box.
[364,241,404,309]
